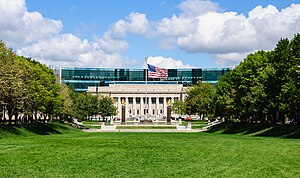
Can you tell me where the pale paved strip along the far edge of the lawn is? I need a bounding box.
[82,129,206,132]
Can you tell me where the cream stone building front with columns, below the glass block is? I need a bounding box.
[88,84,187,118]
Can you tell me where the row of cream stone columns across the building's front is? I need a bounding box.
[117,97,179,118]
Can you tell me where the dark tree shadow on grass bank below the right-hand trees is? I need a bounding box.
[207,123,300,139]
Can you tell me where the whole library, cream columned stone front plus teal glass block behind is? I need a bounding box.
[59,64,230,119]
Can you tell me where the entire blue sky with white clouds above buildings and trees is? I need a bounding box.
[0,0,300,68]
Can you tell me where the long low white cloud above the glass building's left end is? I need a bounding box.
[17,34,130,67]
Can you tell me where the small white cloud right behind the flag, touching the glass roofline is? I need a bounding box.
[147,56,193,69]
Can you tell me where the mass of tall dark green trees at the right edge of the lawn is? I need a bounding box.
[214,34,300,123]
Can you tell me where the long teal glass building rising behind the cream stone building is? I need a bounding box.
[59,68,230,91]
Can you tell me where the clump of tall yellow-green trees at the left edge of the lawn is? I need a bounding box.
[0,41,62,123]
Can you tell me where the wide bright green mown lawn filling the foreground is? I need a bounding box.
[0,124,300,178]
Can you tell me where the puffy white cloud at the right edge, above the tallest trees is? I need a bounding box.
[248,4,300,50]
